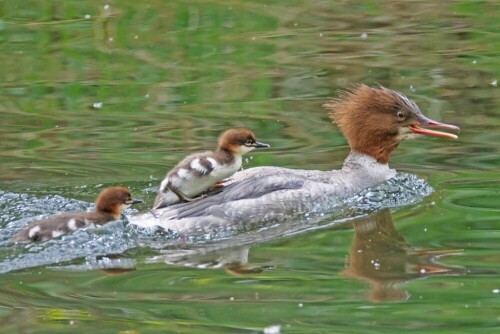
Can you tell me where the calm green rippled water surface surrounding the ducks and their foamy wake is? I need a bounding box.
[0,0,500,333]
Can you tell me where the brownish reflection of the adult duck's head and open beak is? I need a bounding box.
[341,209,465,302]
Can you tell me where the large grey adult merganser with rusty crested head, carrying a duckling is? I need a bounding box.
[129,85,460,234]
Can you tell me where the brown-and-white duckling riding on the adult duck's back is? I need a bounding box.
[153,128,269,209]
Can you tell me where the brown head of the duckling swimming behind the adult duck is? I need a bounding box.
[95,187,142,219]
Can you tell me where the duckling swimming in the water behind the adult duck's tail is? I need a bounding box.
[11,187,142,242]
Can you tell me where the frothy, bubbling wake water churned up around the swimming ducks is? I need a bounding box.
[0,173,433,273]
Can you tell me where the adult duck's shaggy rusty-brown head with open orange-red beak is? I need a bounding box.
[325,85,460,164]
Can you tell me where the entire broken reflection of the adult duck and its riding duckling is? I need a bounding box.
[138,209,465,290]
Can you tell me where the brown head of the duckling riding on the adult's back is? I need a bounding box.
[218,128,270,155]
